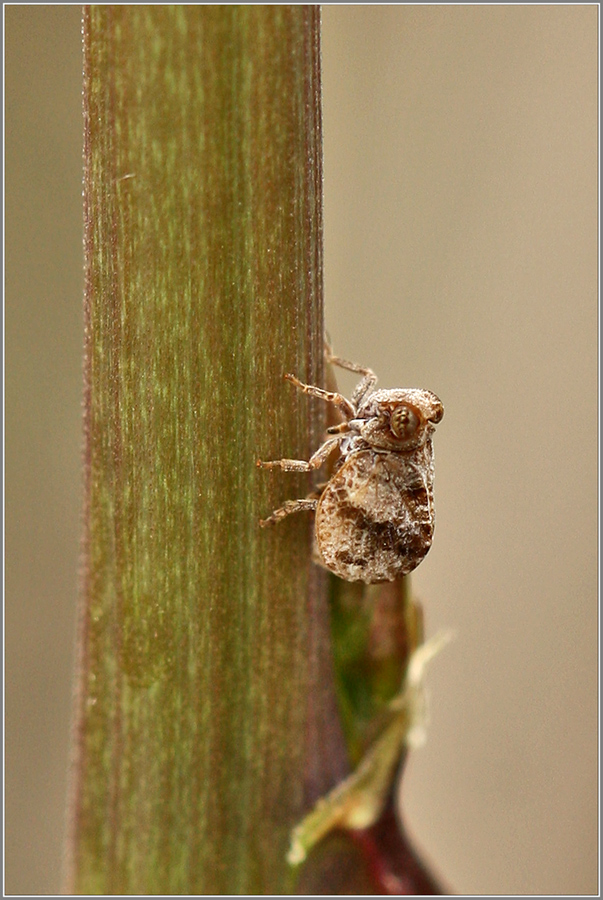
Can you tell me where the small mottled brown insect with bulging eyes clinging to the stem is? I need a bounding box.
[257,353,444,584]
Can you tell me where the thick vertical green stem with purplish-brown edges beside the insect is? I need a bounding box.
[66,5,347,894]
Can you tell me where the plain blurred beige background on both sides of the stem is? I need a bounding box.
[6,5,598,894]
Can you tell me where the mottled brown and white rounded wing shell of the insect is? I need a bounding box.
[316,442,435,584]
